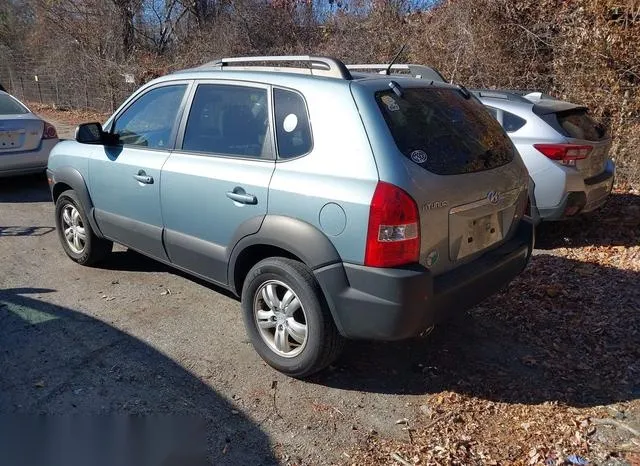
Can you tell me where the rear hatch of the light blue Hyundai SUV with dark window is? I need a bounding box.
[375,84,528,274]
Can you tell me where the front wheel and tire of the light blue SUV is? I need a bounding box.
[56,190,113,265]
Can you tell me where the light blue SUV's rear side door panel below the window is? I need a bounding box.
[161,151,275,283]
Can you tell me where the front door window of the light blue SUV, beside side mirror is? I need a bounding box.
[113,84,187,149]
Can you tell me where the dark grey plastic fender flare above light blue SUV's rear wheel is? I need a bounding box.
[227,215,341,295]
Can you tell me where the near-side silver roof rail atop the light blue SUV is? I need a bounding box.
[198,55,352,80]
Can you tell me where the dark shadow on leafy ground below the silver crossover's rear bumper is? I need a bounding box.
[536,193,640,249]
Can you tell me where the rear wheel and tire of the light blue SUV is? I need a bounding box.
[242,258,344,378]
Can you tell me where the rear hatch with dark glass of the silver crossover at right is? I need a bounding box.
[533,100,611,179]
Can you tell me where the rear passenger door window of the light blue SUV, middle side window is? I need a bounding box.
[182,84,273,159]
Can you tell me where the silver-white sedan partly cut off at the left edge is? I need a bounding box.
[0,91,58,177]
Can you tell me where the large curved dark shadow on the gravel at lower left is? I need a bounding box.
[0,288,276,464]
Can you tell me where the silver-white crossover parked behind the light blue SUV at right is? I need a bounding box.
[473,90,615,221]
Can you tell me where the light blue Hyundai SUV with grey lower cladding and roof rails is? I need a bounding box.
[48,57,533,377]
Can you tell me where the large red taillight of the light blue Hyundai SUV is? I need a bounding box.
[364,181,420,267]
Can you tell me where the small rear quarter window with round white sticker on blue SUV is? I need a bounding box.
[273,89,313,159]
